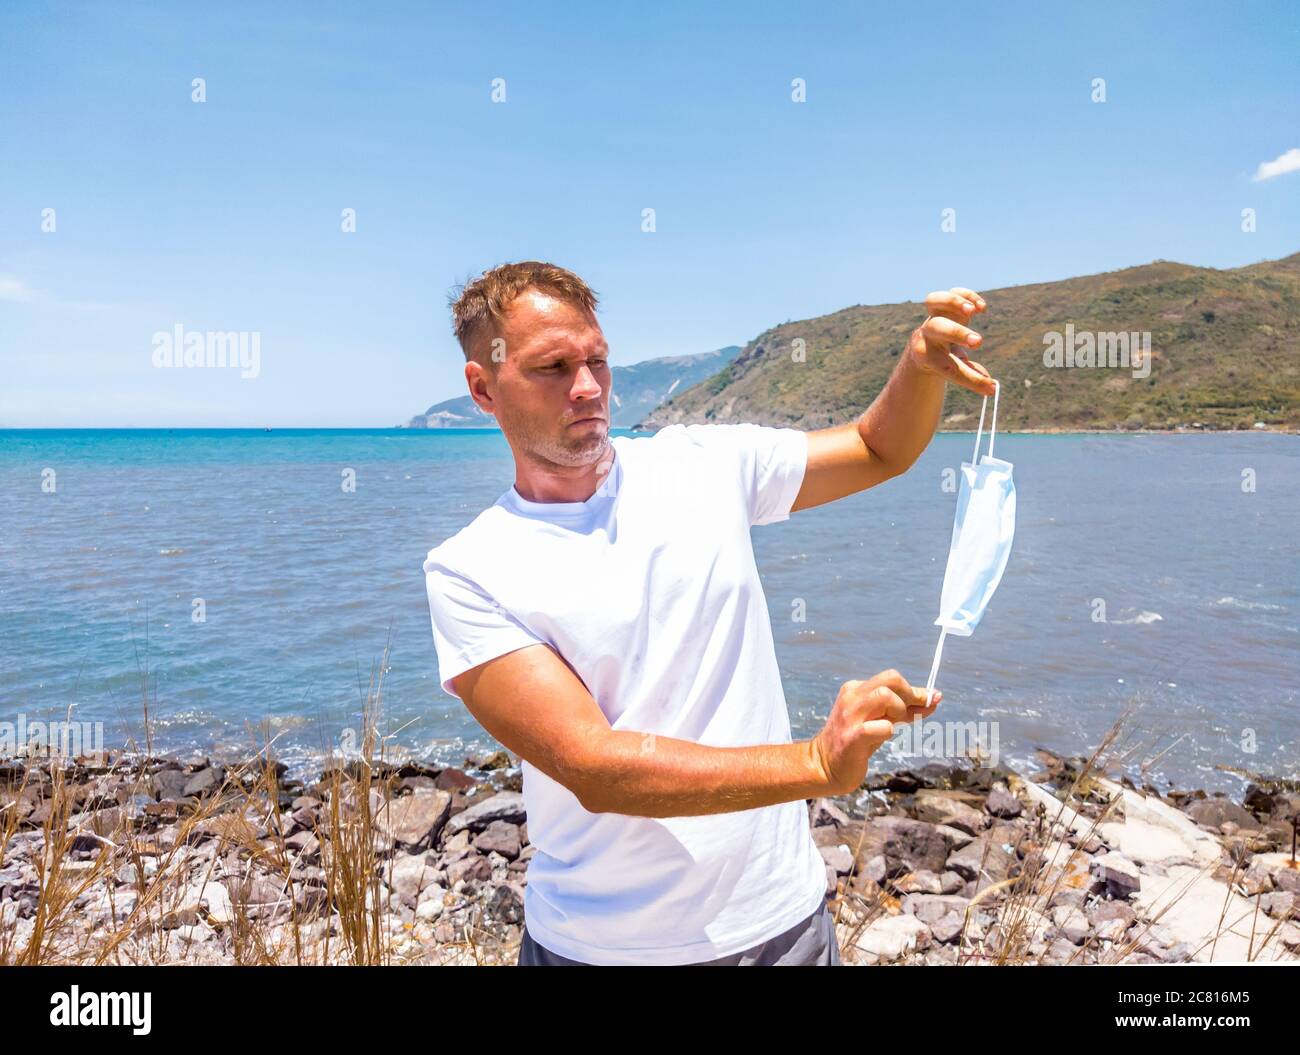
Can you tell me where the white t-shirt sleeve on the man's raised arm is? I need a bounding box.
[686,424,809,525]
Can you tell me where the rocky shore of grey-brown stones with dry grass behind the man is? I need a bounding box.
[0,751,1300,964]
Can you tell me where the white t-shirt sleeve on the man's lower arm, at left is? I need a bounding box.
[424,559,546,696]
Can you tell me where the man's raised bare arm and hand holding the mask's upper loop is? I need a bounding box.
[790,287,993,512]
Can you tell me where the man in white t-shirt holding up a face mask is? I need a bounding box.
[424,261,993,965]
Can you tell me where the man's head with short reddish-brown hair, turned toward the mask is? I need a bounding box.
[451,260,610,466]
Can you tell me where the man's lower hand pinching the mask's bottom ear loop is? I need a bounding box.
[813,670,944,795]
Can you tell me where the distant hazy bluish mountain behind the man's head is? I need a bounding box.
[407,344,741,429]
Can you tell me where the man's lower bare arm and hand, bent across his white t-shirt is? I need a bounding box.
[452,644,937,817]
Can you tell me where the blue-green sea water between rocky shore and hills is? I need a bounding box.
[0,430,1300,789]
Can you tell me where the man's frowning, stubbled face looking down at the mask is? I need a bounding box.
[485,290,611,466]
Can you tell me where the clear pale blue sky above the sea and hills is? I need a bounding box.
[0,0,1300,427]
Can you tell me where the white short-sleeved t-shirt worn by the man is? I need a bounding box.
[424,425,826,964]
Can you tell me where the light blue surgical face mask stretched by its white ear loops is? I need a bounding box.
[926,382,1015,700]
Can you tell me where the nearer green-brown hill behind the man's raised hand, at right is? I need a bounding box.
[640,253,1300,430]
